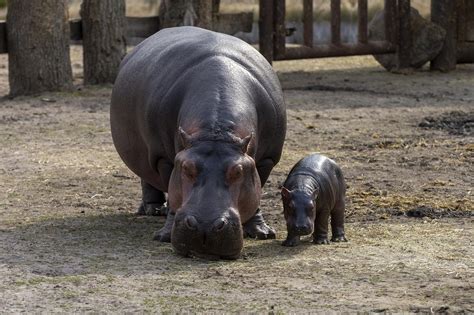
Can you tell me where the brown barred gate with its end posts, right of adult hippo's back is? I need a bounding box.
[259,0,411,68]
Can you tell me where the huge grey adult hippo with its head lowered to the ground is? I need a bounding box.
[110,27,286,259]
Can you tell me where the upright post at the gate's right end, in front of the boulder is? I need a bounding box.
[398,0,412,69]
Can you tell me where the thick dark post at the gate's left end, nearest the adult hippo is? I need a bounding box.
[258,0,274,63]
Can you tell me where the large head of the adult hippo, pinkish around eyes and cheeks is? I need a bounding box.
[168,128,261,259]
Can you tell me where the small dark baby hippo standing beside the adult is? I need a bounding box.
[281,154,347,246]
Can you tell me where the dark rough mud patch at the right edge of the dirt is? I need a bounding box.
[418,111,474,136]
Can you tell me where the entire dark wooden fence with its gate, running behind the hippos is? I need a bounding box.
[0,0,474,66]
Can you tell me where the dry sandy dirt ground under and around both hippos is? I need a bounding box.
[0,47,474,314]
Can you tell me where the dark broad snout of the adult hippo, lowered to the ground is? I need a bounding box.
[171,212,243,259]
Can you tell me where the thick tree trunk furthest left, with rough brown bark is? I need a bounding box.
[7,0,72,96]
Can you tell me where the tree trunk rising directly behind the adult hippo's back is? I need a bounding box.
[160,0,220,29]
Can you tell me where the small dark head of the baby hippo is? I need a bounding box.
[281,187,317,235]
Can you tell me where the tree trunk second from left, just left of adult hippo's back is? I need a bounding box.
[81,0,126,84]
